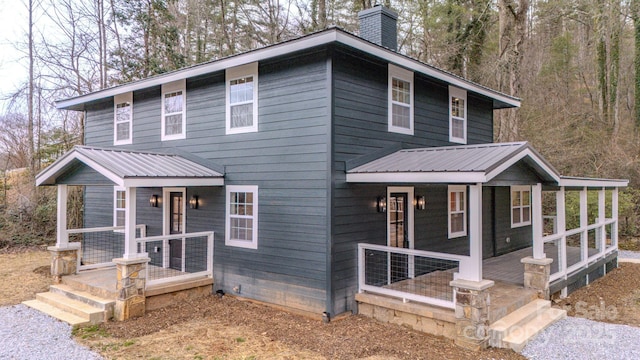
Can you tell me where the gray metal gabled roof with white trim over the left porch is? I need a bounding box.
[36,146,224,187]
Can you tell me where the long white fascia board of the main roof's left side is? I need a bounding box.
[56,30,338,109]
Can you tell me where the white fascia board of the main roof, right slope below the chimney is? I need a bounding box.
[336,32,520,107]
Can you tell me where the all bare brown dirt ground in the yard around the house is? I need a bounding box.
[5,251,640,360]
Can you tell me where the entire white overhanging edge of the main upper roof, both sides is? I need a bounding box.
[56,28,520,110]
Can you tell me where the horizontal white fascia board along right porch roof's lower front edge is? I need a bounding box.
[347,172,486,184]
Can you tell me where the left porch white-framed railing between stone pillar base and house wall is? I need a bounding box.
[136,231,214,286]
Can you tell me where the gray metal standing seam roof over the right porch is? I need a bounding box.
[347,142,552,174]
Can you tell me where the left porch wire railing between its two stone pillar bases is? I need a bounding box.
[66,224,147,270]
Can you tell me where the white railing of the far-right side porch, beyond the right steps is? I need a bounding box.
[542,219,618,281]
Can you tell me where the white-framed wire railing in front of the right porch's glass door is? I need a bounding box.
[358,244,470,309]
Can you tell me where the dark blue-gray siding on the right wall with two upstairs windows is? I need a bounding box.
[331,47,500,313]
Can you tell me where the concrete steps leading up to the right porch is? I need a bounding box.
[489,299,567,352]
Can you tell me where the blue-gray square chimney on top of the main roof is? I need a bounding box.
[358,5,398,51]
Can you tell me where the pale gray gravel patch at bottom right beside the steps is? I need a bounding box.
[522,317,640,360]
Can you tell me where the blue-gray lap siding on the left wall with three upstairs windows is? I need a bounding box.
[86,50,330,313]
